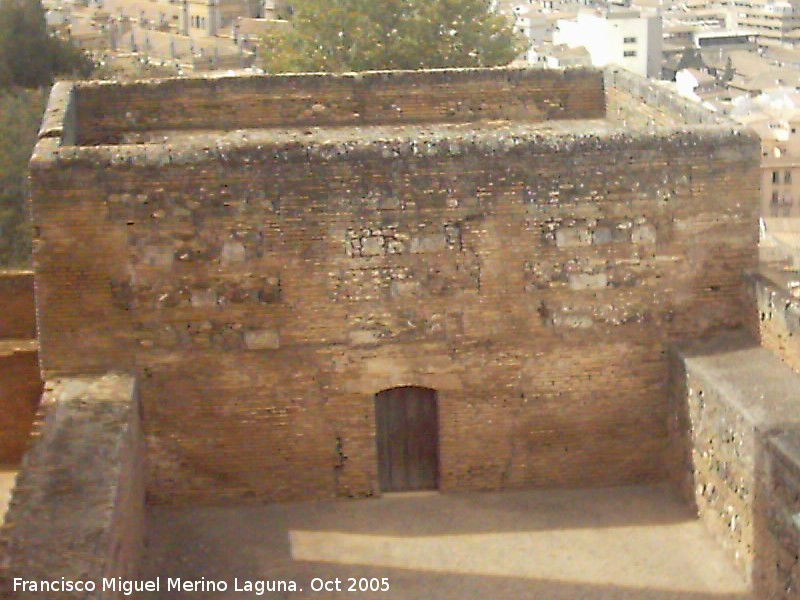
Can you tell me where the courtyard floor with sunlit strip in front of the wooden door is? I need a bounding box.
[144,486,750,600]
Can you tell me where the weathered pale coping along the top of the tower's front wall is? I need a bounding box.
[31,120,757,169]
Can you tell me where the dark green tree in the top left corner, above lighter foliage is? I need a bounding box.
[0,0,92,89]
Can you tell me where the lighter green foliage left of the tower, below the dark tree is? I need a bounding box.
[0,89,46,266]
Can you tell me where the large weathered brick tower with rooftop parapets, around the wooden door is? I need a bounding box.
[32,69,759,502]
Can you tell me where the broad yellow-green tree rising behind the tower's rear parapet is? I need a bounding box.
[261,0,521,72]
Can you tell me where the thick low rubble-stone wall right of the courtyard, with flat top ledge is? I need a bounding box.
[669,333,800,598]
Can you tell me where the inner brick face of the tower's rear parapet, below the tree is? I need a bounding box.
[75,68,605,145]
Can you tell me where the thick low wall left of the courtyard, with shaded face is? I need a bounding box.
[0,375,145,600]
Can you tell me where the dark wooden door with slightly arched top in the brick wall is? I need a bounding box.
[375,386,439,492]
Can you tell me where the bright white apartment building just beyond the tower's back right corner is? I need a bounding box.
[553,10,662,79]
